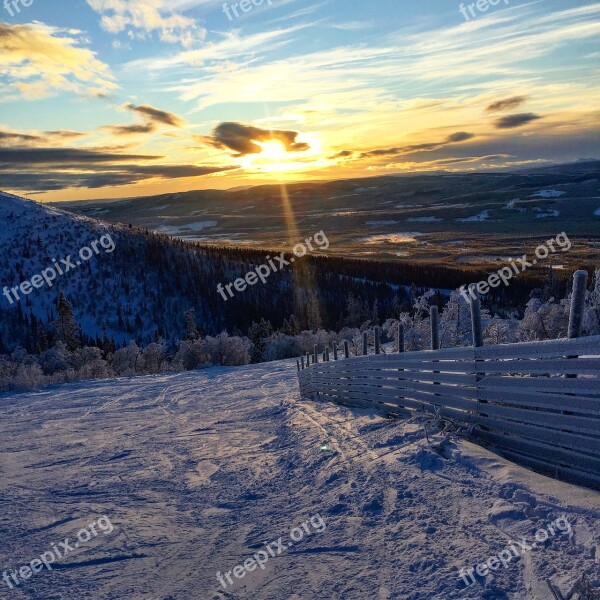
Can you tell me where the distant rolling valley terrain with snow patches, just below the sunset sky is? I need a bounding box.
[59,161,600,268]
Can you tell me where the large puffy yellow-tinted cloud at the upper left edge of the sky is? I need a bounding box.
[0,22,117,101]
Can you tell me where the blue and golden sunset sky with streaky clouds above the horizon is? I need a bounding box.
[0,0,600,201]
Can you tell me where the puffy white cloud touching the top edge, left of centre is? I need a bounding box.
[87,0,206,48]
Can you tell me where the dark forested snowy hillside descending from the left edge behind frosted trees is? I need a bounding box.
[0,192,450,354]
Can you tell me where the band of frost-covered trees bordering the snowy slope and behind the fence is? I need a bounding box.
[0,269,600,391]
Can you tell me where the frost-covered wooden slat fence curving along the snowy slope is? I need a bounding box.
[298,270,600,489]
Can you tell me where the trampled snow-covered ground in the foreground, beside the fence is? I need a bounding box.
[0,361,600,600]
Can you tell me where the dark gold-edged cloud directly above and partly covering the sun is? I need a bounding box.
[204,122,310,156]
